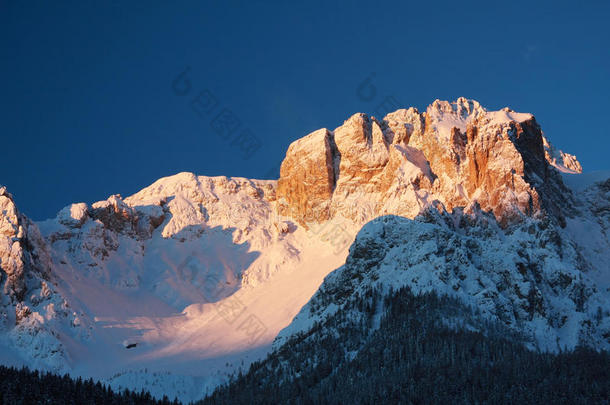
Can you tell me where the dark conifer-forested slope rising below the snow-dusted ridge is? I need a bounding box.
[201,287,610,405]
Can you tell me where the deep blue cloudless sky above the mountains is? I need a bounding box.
[0,0,610,220]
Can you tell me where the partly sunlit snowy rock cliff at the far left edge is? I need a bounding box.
[0,187,87,371]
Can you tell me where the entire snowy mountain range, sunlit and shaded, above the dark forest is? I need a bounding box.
[0,98,610,400]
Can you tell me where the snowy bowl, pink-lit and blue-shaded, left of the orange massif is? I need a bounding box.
[13,173,357,401]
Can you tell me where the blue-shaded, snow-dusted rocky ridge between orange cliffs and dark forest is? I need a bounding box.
[274,202,610,351]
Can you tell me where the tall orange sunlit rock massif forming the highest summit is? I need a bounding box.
[277,98,581,225]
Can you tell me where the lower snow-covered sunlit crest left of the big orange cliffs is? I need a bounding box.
[43,172,275,243]
